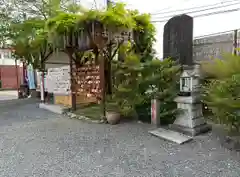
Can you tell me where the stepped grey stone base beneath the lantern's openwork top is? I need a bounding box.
[170,96,211,136]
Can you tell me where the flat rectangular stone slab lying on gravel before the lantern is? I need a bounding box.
[149,128,192,144]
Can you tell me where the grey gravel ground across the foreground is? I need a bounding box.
[0,100,240,177]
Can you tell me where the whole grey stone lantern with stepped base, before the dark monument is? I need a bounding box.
[171,65,209,136]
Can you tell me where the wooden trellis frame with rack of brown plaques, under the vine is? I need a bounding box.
[55,21,131,110]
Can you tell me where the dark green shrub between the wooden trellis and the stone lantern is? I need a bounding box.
[113,55,179,123]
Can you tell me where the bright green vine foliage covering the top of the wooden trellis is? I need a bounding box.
[46,3,135,34]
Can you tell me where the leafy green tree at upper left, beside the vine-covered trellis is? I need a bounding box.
[0,0,83,69]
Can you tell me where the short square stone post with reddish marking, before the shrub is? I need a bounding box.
[151,99,160,127]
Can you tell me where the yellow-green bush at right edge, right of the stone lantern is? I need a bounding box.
[203,55,240,131]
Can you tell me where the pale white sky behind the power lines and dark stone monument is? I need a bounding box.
[81,0,240,58]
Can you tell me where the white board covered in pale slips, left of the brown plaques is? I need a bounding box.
[46,66,71,95]
